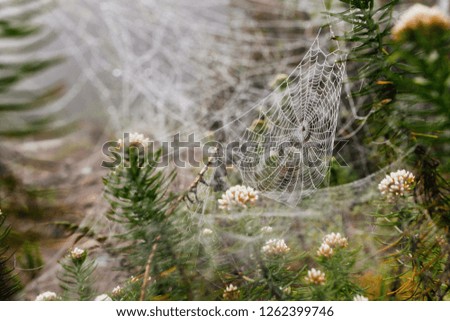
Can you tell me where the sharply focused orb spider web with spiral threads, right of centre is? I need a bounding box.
[233,37,345,205]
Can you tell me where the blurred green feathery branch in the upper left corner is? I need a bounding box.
[0,0,64,137]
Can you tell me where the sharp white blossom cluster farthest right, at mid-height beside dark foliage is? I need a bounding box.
[378,169,415,197]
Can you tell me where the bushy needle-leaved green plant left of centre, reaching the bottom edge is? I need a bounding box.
[104,143,204,299]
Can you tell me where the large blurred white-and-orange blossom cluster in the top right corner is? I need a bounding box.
[391,4,450,40]
